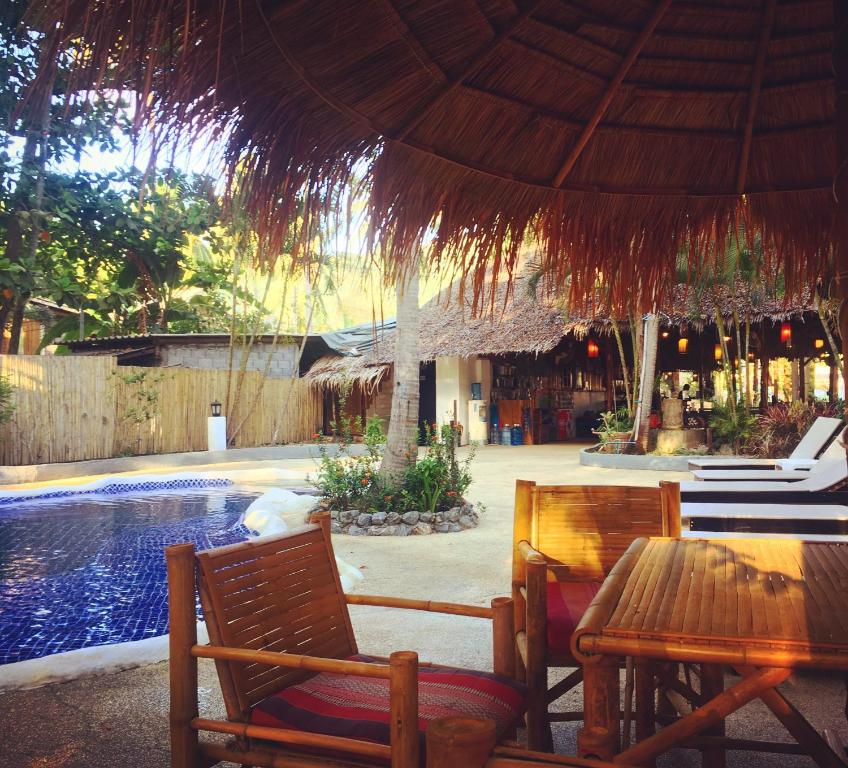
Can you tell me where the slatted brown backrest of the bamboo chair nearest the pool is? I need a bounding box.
[197,525,356,719]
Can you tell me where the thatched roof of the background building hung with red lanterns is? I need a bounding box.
[305,275,816,391]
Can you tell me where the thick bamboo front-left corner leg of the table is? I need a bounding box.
[577,656,620,760]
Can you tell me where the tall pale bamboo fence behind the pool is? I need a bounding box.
[0,355,322,466]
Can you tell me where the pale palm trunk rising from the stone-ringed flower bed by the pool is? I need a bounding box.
[380,261,421,480]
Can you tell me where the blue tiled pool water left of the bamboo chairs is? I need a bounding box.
[0,486,259,664]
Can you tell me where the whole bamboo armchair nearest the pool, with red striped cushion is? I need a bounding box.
[166,515,526,768]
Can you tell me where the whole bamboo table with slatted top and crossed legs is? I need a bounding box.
[572,539,848,768]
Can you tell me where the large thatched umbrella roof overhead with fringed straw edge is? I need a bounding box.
[37,0,836,308]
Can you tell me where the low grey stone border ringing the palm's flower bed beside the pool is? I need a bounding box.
[330,503,480,536]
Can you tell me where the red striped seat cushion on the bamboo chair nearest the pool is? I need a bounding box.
[250,656,527,747]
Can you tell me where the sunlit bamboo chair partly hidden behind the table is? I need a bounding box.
[512,480,680,750]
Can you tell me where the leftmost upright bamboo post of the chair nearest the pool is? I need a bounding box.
[165,544,198,768]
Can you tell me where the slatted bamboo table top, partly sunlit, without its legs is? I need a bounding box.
[574,539,848,669]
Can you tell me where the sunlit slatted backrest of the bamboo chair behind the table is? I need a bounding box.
[516,483,679,581]
